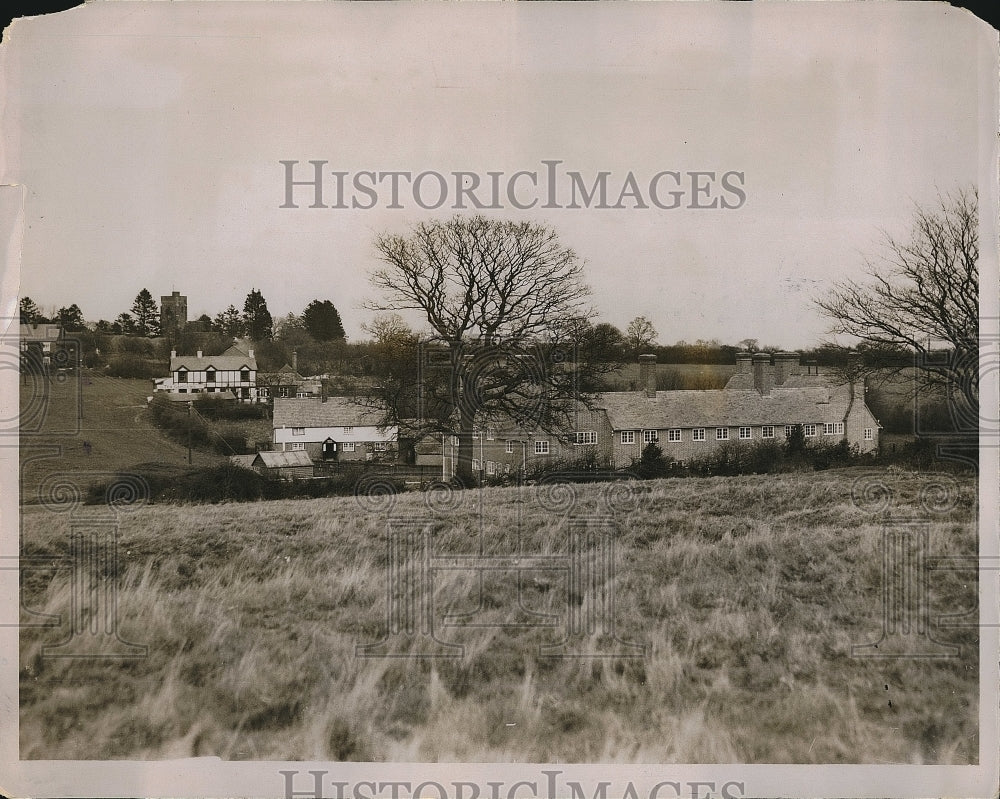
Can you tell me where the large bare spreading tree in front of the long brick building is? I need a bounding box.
[369,216,589,485]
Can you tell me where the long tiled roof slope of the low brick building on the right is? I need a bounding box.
[597,386,850,430]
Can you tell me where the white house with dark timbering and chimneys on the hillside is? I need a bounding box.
[153,345,260,402]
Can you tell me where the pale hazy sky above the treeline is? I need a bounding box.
[0,0,996,348]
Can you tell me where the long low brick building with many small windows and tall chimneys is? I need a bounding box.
[414,352,880,477]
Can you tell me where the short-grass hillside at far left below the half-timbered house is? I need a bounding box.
[21,370,222,502]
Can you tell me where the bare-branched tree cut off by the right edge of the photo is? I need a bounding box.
[816,188,979,408]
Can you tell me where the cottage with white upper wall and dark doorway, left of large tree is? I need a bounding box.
[272,396,399,462]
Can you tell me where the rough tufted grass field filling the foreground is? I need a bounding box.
[21,472,978,763]
